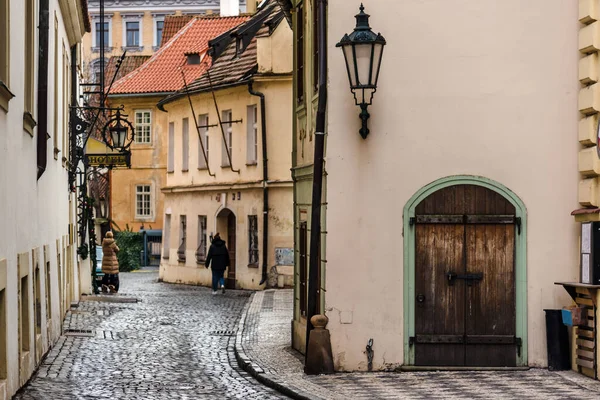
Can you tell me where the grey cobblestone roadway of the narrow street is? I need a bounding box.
[15,269,285,400]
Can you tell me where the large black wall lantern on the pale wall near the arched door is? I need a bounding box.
[336,4,385,139]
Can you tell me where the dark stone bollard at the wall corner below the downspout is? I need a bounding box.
[304,314,335,375]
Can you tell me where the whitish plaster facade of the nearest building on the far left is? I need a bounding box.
[0,0,80,399]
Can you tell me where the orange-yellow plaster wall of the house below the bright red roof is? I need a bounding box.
[109,97,168,231]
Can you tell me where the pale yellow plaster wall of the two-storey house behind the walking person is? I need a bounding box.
[160,76,293,289]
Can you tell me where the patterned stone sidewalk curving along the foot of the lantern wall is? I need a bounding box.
[236,290,600,400]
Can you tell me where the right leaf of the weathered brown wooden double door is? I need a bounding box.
[465,225,516,366]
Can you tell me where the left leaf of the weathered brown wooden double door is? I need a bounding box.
[415,224,465,365]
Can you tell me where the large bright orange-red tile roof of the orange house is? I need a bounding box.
[110,16,248,95]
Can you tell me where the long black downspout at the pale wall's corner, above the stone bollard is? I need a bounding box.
[305,0,327,357]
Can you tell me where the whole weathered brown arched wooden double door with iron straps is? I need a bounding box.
[411,185,521,367]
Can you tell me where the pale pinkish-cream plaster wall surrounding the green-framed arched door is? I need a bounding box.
[326,0,579,370]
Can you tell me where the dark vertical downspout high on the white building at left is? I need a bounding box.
[37,0,50,179]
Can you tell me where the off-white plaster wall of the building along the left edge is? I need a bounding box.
[0,0,84,398]
